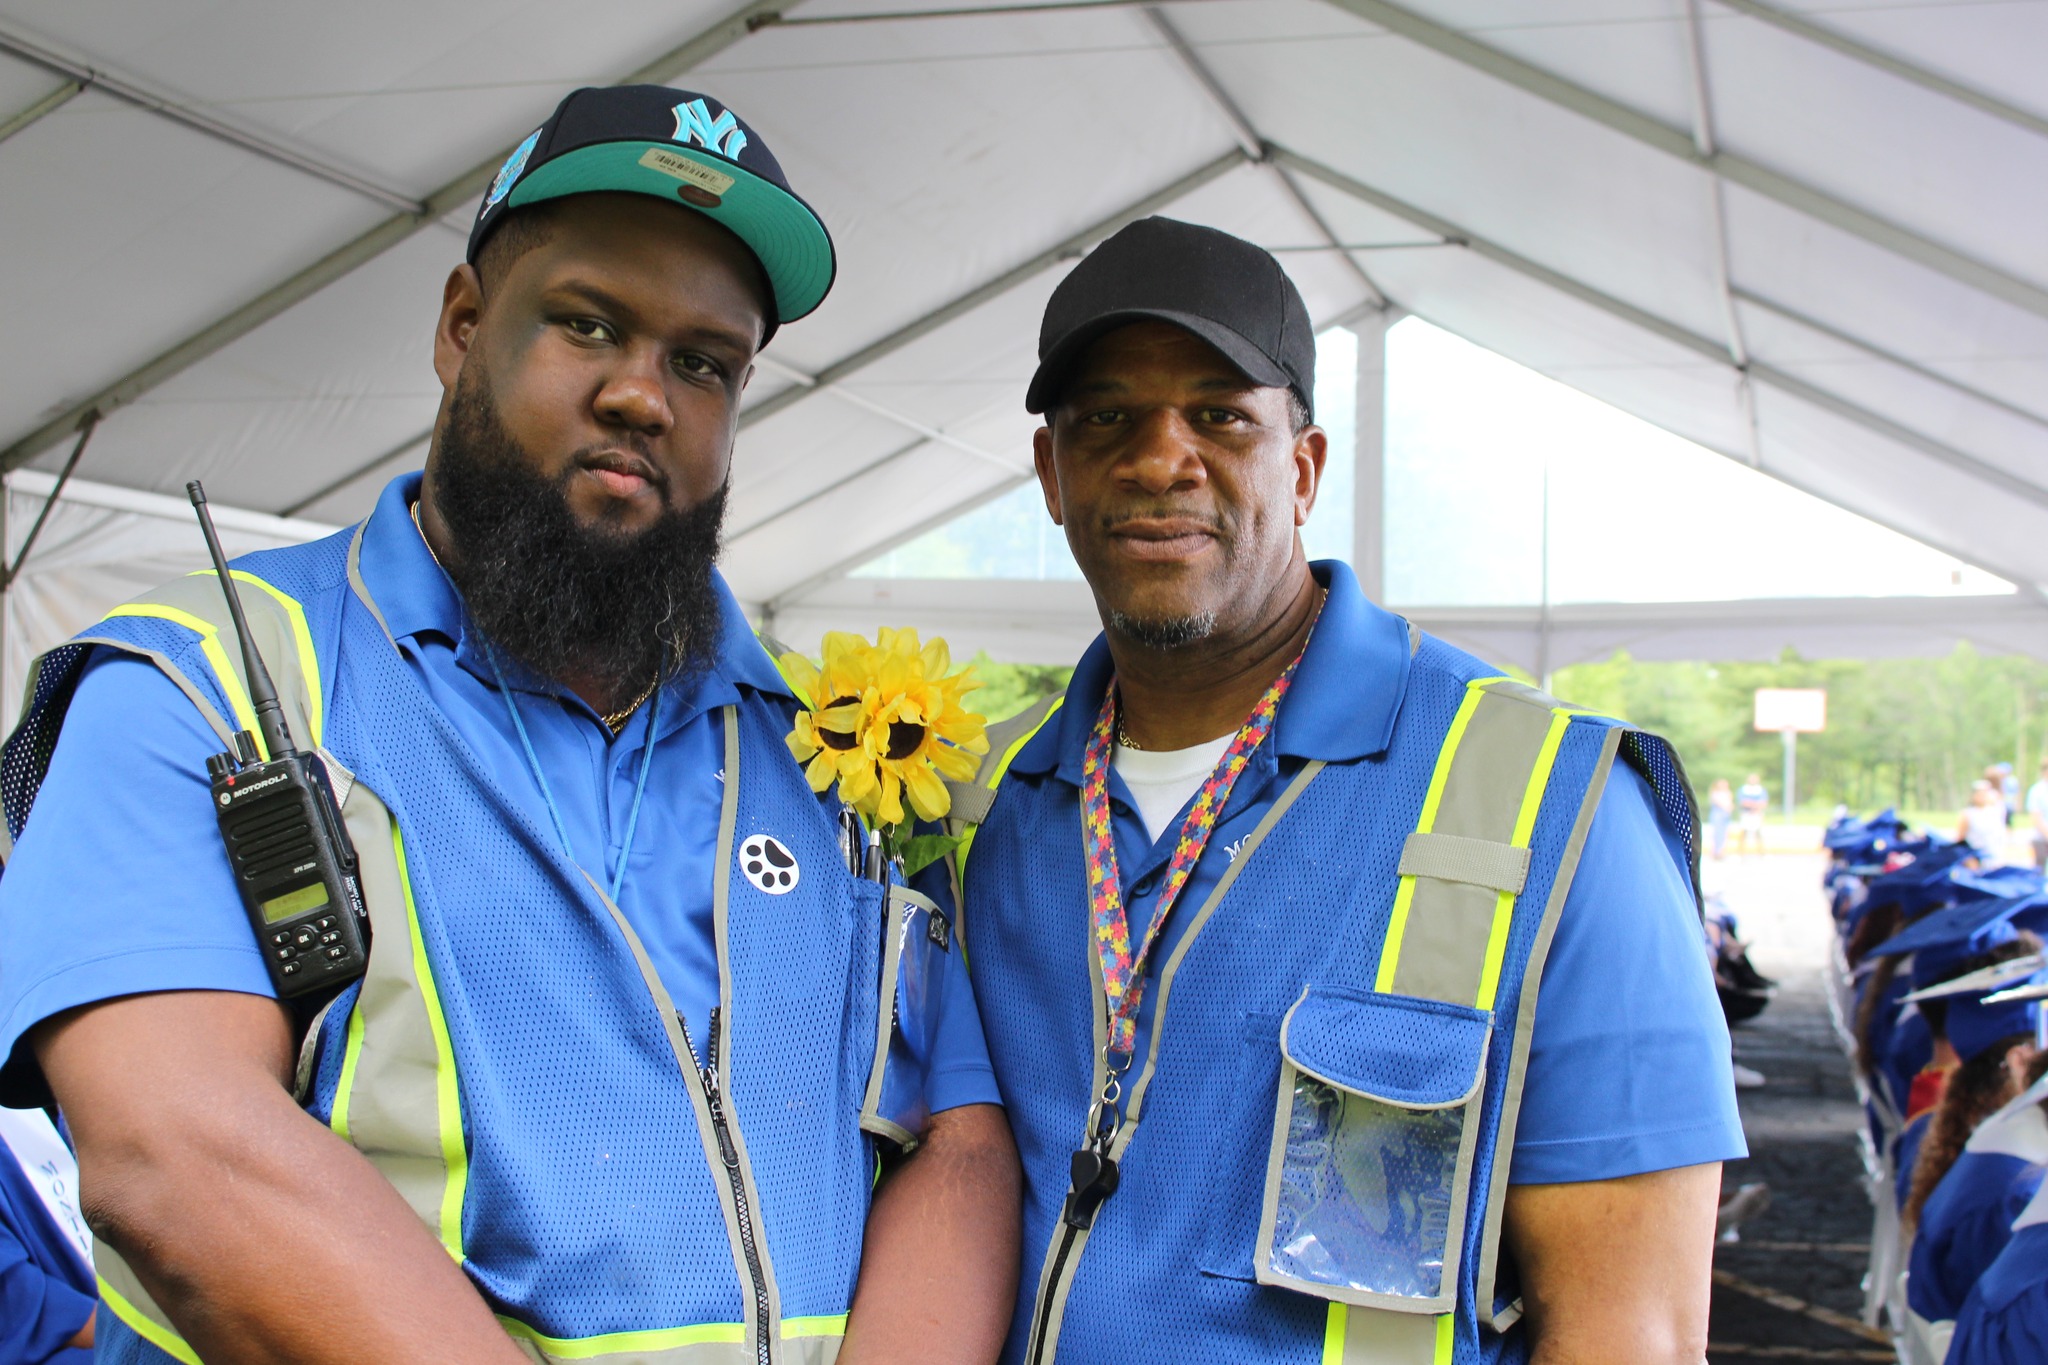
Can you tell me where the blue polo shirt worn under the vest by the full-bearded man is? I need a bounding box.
[0,475,997,1113]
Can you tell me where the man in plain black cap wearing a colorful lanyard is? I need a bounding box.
[963,219,1743,1365]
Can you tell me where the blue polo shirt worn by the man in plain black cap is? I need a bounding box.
[983,561,1747,1185]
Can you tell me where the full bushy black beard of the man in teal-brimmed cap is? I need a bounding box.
[434,370,725,700]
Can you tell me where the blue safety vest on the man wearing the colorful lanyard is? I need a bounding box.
[961,630,1704,1365]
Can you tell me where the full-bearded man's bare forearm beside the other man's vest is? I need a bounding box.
[840,1105,1024,1365]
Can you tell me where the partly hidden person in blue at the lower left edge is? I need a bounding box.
[0,1109,98,1365]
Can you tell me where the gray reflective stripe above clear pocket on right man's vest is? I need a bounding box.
[1380,681,1556,1009]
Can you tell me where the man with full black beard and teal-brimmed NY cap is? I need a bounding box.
[0,86,1018,1365]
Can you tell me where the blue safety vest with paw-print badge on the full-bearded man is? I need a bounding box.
[0,526,907,1365]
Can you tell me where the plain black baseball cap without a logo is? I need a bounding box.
[1024,217,1315,417]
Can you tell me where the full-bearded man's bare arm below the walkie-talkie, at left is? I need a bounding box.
[33,990,526,1365]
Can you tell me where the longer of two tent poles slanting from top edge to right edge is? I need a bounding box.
[1325,0,2048,317]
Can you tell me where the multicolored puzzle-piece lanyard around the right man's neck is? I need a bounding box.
[1067,606,1321,1228]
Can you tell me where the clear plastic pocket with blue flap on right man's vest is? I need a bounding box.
[1255,986,1493,1314]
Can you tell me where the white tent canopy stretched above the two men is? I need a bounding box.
[0,0,2048,679]
